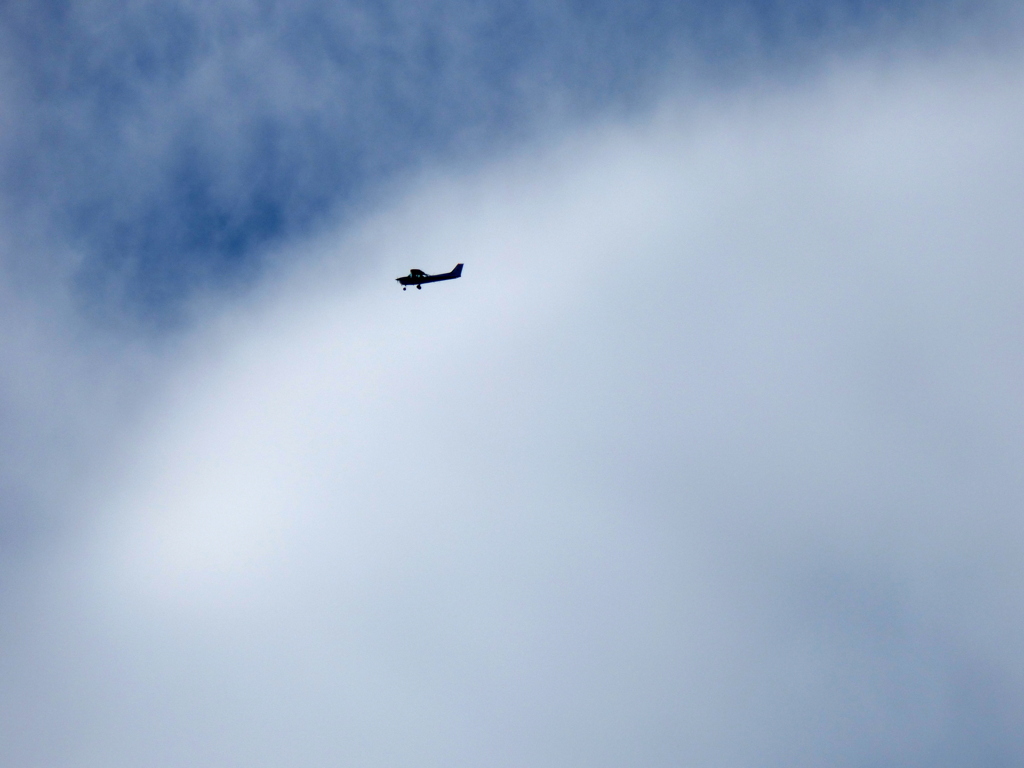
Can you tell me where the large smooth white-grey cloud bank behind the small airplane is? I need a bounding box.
[0,27,1024,766]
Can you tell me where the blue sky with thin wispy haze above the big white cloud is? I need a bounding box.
[0,0,1005,322]
